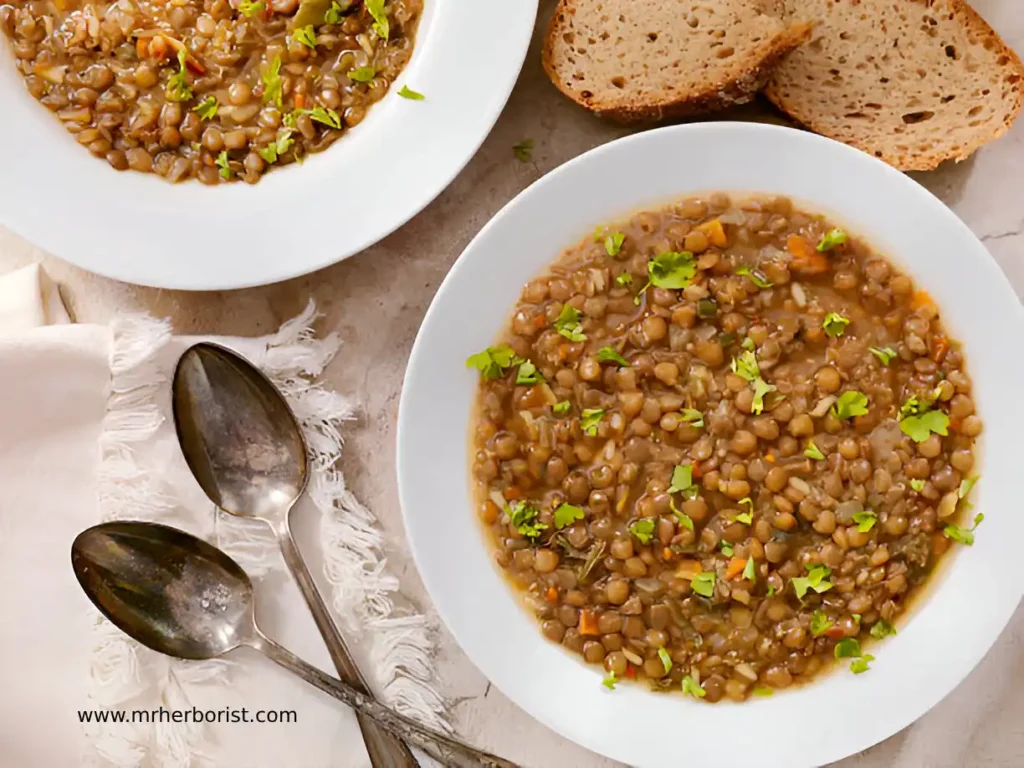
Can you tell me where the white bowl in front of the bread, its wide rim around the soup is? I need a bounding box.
[398,123,1024,768]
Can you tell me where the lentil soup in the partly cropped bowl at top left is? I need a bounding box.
[0,0,422,184]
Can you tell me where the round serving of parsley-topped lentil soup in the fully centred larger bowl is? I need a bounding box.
[467,194,982,701]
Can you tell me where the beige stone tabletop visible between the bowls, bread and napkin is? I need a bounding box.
[0,0,1024,768]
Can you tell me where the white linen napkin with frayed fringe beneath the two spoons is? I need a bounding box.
[0,266,447,768]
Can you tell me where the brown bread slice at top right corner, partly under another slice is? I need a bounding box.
[765,0,1024,171]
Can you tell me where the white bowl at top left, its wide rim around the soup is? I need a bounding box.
[0,0,537,290]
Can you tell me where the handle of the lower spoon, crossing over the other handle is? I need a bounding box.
[247,629,518,768]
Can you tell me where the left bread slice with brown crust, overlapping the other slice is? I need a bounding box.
[542,0,810,122]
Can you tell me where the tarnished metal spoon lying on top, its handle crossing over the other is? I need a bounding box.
[71,522,517,768]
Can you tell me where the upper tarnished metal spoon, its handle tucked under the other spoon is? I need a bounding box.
[172,343,417,768]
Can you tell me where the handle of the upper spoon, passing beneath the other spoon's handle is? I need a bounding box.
[273,520,418,768]
